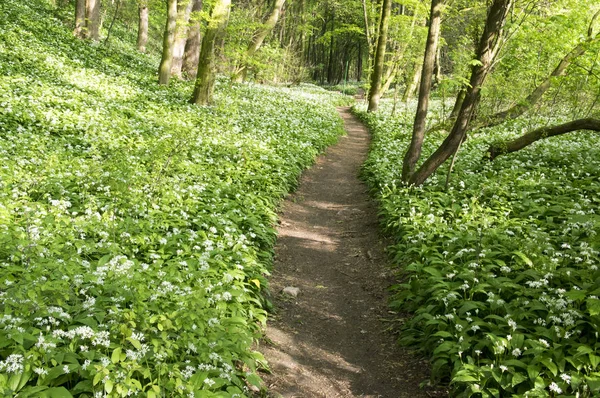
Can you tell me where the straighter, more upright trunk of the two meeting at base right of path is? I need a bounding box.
[402,0,443,181]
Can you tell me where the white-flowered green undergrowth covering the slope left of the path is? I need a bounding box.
[0,0,347,397]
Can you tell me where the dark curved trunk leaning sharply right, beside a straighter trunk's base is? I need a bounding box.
[408,0,513,186]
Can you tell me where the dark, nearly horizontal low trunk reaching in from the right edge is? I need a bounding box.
[486,118,600,160]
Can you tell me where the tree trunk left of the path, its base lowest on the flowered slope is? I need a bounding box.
[190,0,231,105]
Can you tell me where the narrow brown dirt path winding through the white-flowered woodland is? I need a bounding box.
[261,108,436,398]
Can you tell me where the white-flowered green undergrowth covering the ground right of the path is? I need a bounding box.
[357,106,600,397]
